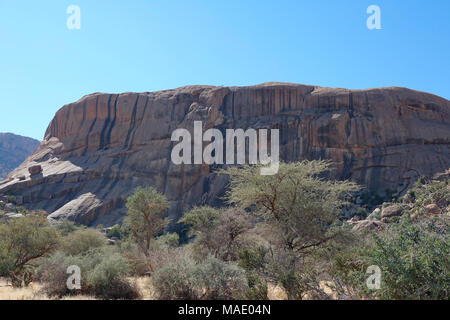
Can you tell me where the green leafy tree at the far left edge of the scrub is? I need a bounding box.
[0,213,60,286]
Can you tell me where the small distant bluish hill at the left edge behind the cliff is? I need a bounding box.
[0,133,39,180]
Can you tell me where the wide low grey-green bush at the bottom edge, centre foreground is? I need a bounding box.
[152,256,247,300]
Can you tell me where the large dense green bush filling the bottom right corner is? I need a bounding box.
[367,217,450,300]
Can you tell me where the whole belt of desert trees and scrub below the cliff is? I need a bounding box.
[0,161,450,300]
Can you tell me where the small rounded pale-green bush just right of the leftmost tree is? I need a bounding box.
[62,229,106,256]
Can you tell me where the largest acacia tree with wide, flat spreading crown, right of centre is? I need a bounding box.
[221,160,358,298]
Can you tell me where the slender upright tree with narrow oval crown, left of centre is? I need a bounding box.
[125,187,169,274]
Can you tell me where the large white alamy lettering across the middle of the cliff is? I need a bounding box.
[171,121,280,175]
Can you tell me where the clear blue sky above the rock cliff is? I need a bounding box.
[0,0,450,139]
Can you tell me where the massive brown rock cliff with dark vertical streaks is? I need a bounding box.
[0,83,450,226]
